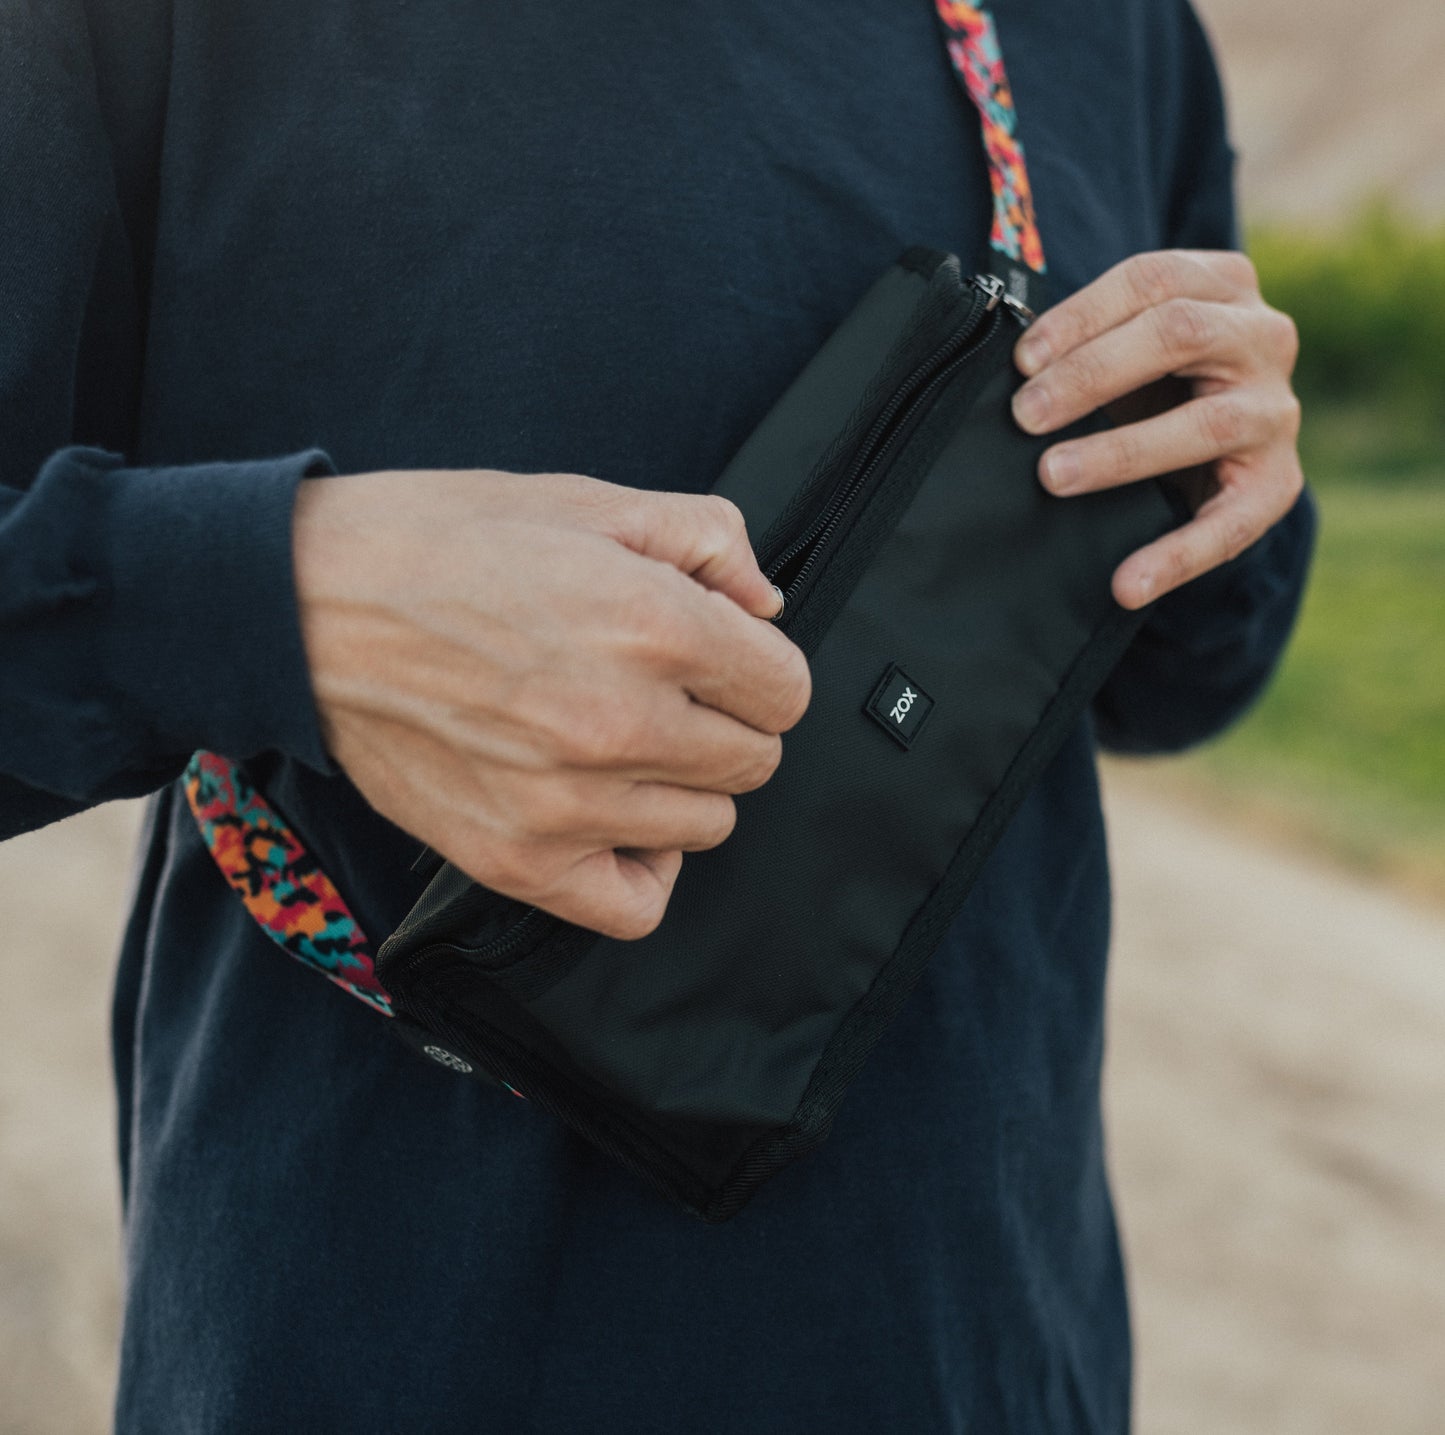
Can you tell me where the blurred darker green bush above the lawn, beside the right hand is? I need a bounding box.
[1250,202,1445,484]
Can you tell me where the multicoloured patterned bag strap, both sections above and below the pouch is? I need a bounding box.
[182,0,1045,1016]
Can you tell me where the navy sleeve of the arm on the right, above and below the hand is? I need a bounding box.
[1094,0,1318,753]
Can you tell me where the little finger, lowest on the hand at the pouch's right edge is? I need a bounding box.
[1113,461,1303,608]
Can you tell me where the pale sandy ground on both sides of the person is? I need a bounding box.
[0,791,1445,1435]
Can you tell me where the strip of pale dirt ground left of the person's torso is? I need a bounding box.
[0,803,139,1435]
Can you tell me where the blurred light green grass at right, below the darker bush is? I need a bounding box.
[1185,482,1445,897]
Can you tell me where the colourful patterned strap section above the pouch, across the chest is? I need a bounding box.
[933,0,1046,275]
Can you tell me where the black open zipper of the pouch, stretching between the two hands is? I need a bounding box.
[766,275,1033,623]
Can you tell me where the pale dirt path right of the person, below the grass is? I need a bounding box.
[1108,769,1445,1435]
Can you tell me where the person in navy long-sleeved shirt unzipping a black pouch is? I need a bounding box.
[0,0,1315,1435]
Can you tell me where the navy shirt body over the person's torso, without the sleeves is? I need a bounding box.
[104,0,1196,1435]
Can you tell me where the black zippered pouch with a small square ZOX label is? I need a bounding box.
[377,249,1183,1221]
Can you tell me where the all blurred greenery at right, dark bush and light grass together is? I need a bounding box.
[1150,205,1445,899]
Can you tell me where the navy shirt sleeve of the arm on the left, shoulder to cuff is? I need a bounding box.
[0,0,335,838]
